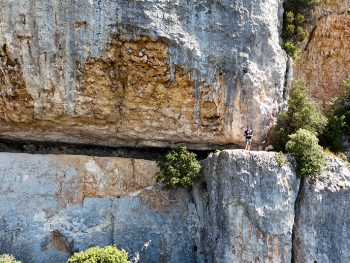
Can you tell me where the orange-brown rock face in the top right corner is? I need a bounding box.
[295,0,350,107]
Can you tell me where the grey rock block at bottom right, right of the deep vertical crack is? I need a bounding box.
[293,160,350,263]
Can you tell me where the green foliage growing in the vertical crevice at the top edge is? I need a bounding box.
[283,0,321,58]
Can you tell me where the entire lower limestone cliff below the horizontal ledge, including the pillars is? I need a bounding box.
[0,150,350,263]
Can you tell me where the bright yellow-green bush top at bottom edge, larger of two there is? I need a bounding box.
[67,246,130,263]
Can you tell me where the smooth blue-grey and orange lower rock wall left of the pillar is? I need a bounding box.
[0,153,198,263]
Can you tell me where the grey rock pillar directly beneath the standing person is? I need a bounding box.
[197,151,299,263]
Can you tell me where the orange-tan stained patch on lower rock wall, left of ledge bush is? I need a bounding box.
[48,156,158,207]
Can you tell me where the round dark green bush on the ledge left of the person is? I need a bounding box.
[155,146,201,189]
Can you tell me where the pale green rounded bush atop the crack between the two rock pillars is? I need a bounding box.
[286,129,325,176]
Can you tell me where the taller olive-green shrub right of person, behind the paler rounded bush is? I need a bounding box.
[273,81,327,151]
